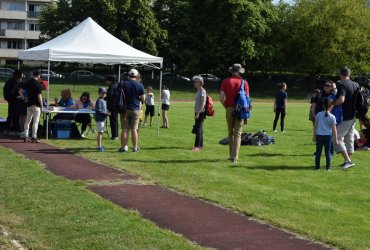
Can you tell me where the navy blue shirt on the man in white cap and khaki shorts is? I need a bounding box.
[123,80,144,111]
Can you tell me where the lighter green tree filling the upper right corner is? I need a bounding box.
[282,0,370,75]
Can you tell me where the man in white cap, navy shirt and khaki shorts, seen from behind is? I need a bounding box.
[118,69,144,152]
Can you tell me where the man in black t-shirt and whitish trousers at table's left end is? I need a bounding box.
[24,71,43,143]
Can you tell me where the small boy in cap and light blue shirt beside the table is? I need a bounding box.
[95,87,110,151]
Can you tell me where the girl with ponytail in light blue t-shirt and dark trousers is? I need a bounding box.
[312,98,338,171]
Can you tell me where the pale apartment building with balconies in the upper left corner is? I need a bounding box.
[0,0,55,65]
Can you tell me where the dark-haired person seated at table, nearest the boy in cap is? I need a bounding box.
[72,92,95,138]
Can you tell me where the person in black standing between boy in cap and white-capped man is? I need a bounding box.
[106,76,118,140]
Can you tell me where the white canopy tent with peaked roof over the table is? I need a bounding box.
[18,17,163,137]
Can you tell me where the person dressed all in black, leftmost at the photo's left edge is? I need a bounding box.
[3,70,22,133]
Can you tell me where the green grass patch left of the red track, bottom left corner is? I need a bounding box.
[0,147,198,249]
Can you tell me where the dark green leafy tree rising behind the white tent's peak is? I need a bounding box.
[40,0,166,55]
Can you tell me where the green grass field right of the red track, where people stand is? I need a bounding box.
[0,82,370,249]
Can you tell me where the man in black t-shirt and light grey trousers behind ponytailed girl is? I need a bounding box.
[333,67,358,170]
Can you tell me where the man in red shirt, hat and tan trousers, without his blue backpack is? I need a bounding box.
[220,63,249,163]
